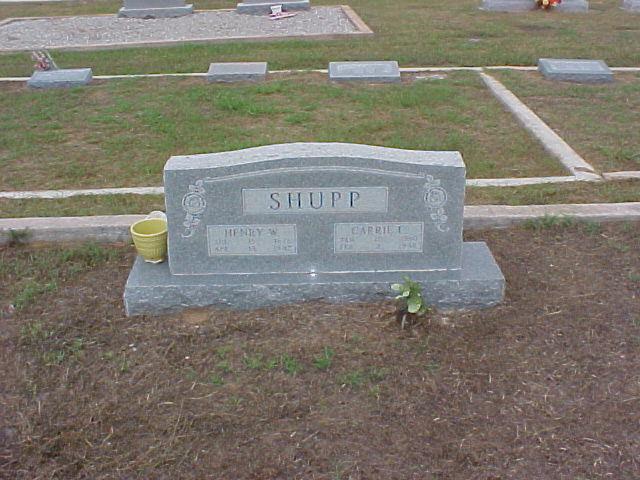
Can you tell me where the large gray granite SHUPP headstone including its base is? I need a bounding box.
[124,143,505,315]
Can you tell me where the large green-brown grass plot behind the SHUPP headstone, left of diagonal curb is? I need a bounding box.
[0,72,564,190]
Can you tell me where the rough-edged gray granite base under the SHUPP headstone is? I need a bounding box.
[124,242,505,316]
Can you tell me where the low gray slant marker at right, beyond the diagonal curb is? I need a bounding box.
[538,58,613,83]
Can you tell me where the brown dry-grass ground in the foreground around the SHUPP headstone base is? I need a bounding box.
[0,217,640,480]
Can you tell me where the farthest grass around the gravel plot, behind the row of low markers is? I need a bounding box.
[0,0,640,76]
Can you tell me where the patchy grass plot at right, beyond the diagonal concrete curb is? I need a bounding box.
[492,71,640,172]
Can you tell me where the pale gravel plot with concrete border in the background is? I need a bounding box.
[0,7,359,51]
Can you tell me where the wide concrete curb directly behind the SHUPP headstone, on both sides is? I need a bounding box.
[0,202,640,245]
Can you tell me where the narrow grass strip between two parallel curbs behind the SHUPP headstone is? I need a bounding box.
[0,180,640,218]
